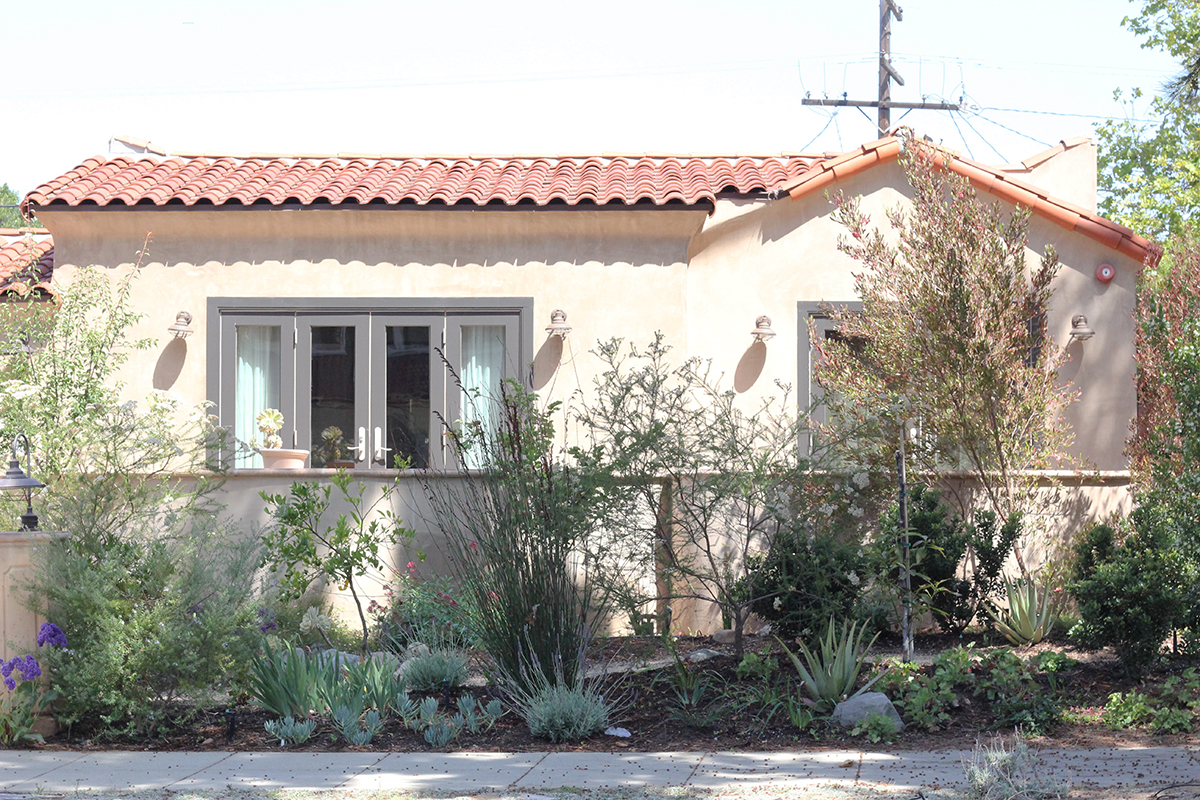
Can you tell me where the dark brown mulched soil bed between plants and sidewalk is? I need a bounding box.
[30,634,1200,752]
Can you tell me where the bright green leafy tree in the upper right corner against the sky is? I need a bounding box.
[1096,0,1200,240]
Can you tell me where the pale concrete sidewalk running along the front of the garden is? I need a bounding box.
[0,747,1200,794]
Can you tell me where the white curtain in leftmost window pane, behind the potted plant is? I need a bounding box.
[234,325,280,468]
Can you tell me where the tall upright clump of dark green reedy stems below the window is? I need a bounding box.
[425,381,608,686]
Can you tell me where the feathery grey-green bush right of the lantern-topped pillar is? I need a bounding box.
[35,515,258,734]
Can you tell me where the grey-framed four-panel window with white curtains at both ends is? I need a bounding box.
[209,297,533,469]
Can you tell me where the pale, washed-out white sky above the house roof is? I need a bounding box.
[0,0,1176,193]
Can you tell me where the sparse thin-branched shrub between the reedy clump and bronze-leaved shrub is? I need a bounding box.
[577,335,866,658]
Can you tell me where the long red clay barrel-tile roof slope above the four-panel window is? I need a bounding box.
[25,156,811,209]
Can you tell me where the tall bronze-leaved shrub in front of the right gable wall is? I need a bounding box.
[814,136,1070,527]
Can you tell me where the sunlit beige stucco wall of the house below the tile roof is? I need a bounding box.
[38,145,1140,633]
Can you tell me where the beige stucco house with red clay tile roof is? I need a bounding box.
[7,131,1159,633]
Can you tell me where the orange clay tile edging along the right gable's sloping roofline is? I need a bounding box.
[775,136,1163,266]
